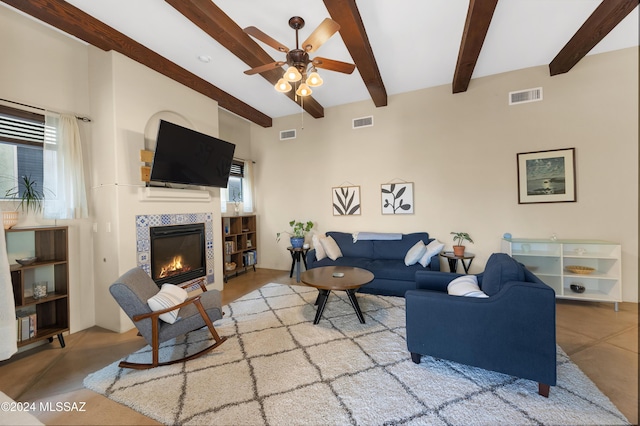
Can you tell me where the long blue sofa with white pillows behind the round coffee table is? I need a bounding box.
[306,232,440,297]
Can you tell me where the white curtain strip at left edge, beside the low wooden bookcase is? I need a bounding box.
[0,218,18,361]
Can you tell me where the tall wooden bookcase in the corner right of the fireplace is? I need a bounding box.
[222,215,258,282]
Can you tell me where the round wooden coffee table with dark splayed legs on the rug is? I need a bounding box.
[300,266,374,324]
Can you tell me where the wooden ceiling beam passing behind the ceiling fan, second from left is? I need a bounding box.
[165,0,324,118]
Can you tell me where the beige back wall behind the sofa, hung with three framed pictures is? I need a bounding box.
[252,49,638,302]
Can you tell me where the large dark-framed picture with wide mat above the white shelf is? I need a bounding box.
[517,148,576,204]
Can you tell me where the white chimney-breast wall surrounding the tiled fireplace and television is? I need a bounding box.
[90,48,223,331]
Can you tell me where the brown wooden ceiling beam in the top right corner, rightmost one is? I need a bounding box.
[549,0,640,76]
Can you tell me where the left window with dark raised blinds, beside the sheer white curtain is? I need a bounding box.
[0,105,45,198]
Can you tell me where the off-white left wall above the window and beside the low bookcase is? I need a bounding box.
[0,7,95,333]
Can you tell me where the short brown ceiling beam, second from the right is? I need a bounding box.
[452,0,498,93]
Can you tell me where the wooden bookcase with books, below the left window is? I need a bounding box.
[5,226,69,347]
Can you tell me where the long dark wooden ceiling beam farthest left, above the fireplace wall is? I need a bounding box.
[0,0,272,127]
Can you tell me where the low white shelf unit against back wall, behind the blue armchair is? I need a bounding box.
[501,238,622,311]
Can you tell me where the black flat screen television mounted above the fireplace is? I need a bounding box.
[150,120,236,188]
